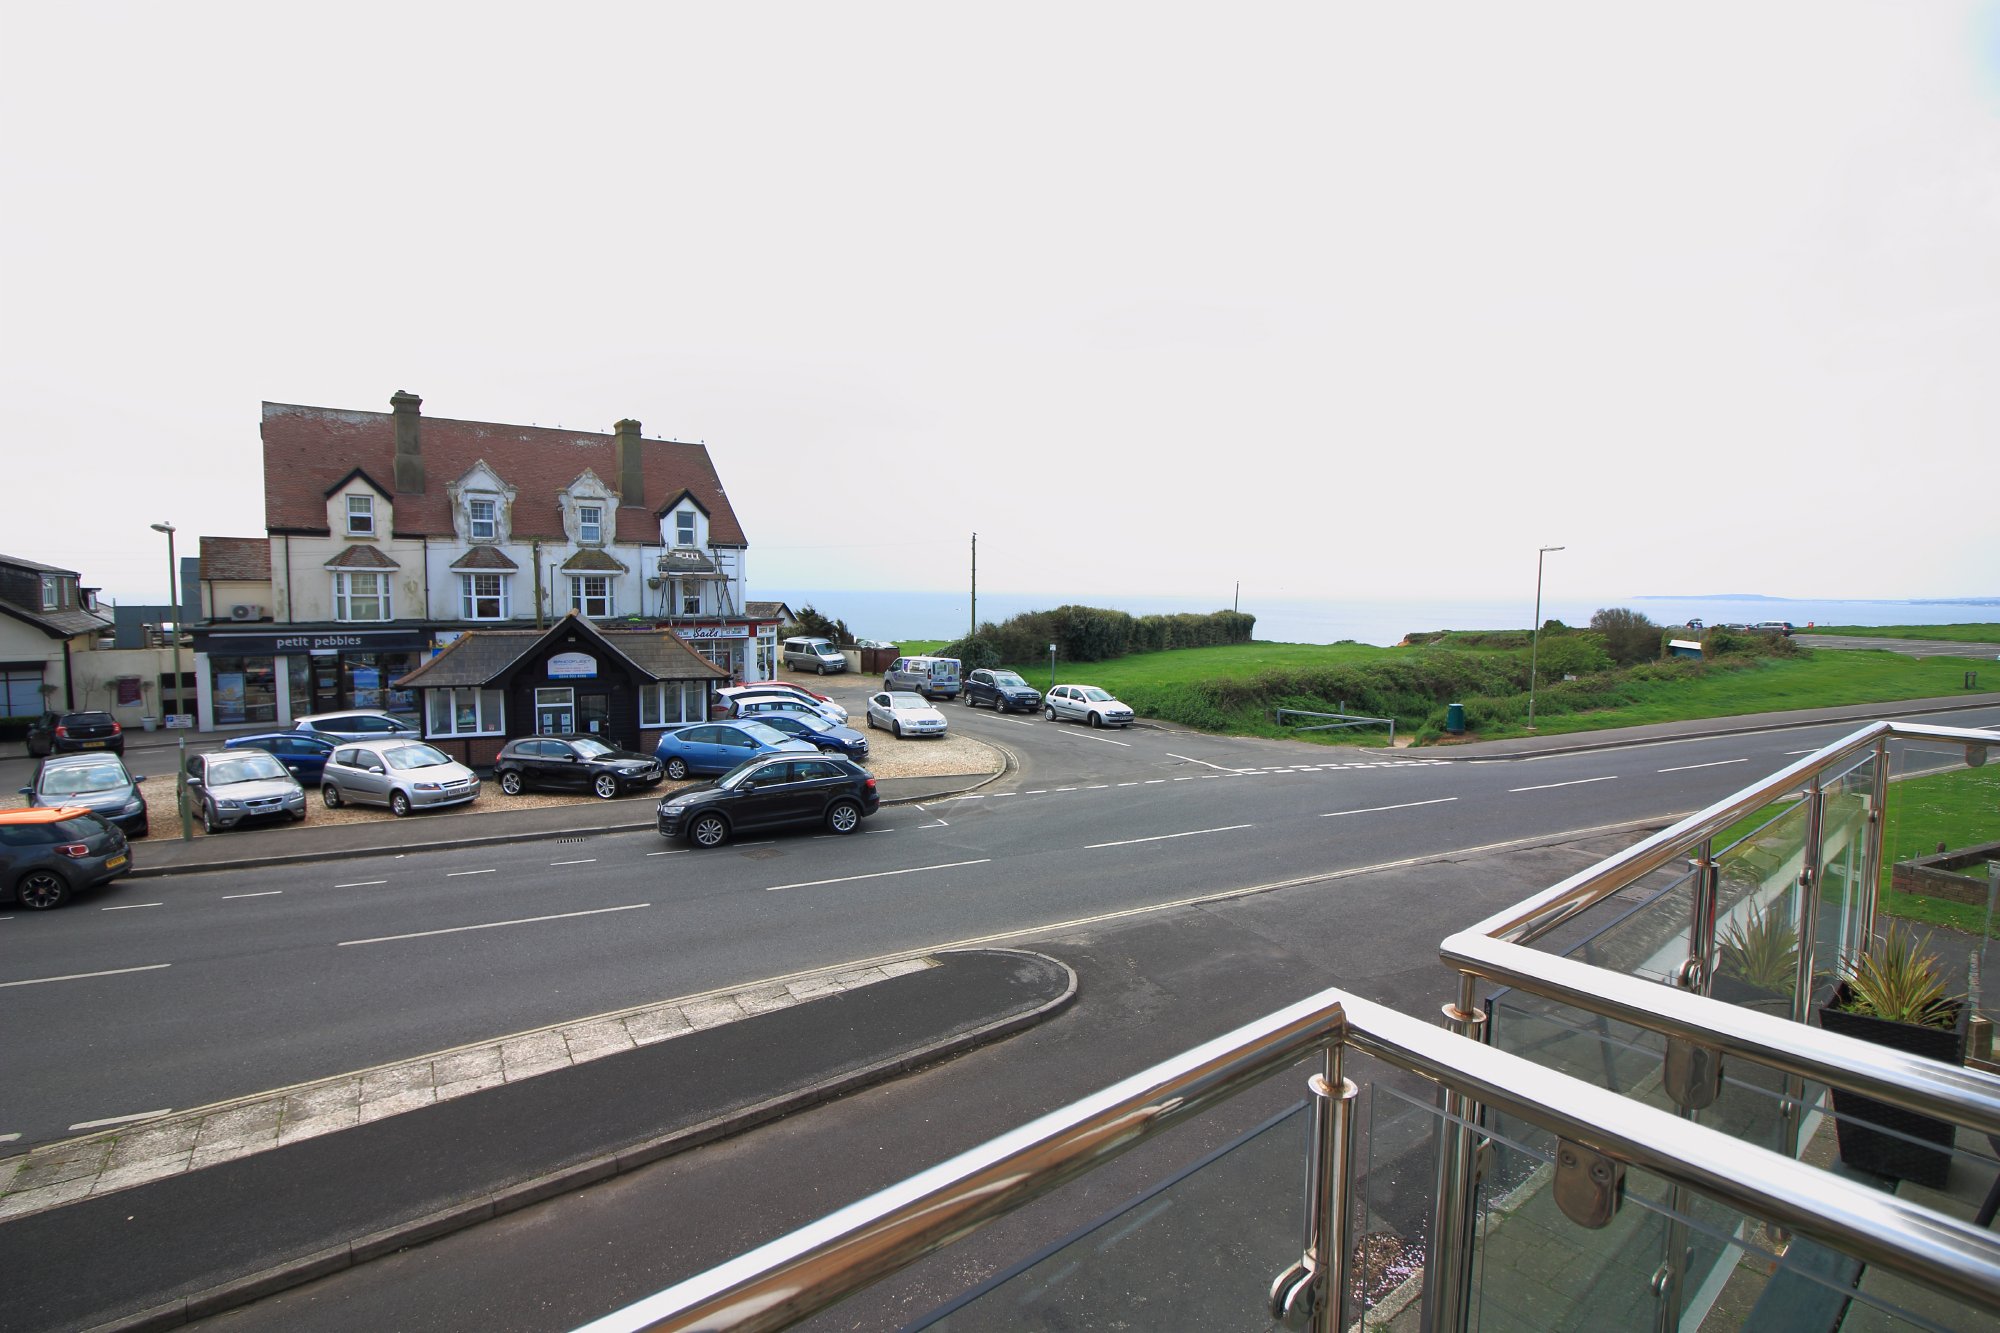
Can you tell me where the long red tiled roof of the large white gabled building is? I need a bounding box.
[262,402,748,546]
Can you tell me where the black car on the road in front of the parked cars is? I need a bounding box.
[660,755,882,847]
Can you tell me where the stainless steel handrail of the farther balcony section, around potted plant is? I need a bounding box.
[1438,723,2000,1133]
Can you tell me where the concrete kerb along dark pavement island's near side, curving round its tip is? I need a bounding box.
[88,951,1076,1333]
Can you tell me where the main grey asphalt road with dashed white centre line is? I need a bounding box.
[0,688,2000,1145]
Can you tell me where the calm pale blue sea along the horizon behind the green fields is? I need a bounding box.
[756,588,2000,644]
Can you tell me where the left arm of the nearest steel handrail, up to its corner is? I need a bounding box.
[586,991,1346,1333]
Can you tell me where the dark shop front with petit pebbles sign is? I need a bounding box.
[194,626,432,731]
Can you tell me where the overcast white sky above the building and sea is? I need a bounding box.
[0,0,2000,608]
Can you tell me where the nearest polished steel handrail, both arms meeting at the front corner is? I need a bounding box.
[584,991,2000,1333]
